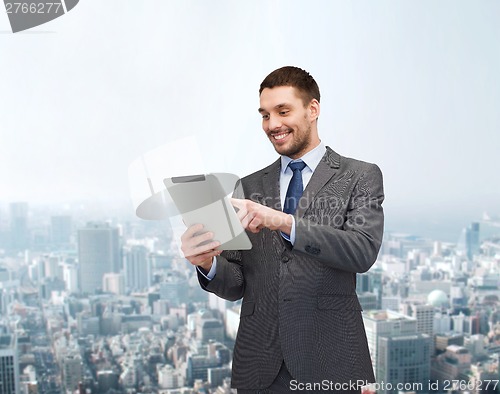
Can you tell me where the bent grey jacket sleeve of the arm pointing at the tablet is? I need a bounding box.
[294,164,384,272]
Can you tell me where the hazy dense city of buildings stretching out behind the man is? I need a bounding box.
[0,195,500,394]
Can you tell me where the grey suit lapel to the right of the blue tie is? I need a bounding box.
[294,146,340,218]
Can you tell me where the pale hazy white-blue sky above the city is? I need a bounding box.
[0,0,500,237]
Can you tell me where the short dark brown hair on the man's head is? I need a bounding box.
[259,66,320,107]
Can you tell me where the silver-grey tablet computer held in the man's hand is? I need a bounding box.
[163,174,252,250]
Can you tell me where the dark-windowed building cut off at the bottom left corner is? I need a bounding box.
[0,335,20,394]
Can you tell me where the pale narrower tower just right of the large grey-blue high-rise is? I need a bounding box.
[123,245,152,291]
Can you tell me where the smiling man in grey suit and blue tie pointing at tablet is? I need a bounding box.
[182,67,384,393]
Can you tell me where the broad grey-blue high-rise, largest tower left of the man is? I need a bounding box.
[78,223,121,294]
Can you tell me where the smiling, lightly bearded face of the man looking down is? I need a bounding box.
[259,86,319,159]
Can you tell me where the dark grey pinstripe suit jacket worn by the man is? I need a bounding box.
[198,147,384,389]
